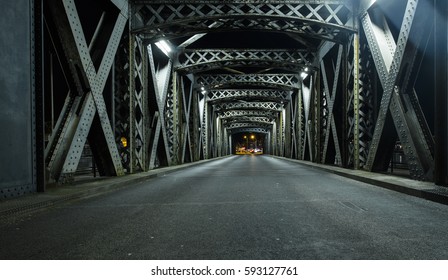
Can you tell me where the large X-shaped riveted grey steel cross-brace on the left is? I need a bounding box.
[50,0,128,181]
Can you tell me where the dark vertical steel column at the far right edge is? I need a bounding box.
[434,0,448,186]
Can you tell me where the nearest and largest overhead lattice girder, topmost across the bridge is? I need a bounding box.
[131,0,353,41]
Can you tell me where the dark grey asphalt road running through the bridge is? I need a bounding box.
[0,155,448,260]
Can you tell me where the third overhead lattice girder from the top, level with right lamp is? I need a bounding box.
[195,74,300,90]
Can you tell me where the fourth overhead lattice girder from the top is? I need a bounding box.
[208,89,291,102]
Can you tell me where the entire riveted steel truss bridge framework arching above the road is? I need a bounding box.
[0,0,448,199]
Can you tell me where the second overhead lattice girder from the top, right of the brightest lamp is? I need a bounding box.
[175,49,315,73]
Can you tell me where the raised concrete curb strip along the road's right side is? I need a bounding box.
[273,156,448,205]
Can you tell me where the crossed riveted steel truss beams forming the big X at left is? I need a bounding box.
[47,0,128,182]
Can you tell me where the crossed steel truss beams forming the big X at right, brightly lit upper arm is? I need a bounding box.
[362,0,434,180]
